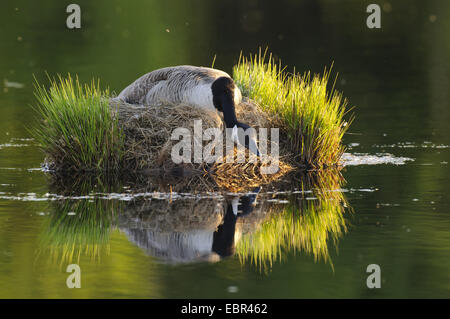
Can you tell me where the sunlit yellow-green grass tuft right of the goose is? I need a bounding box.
[233,50,352,168]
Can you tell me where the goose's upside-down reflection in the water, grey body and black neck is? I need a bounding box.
[120,189,259,263]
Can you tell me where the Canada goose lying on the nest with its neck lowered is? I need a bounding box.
[118,65,260,156]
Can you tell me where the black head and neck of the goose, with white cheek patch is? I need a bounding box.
[211,77,260,156]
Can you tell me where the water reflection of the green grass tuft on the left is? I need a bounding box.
[41,174,120,264]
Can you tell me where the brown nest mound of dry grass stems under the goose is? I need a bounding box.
[110,98,291,192]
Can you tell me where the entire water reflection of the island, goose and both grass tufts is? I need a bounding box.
[37,171,348,276]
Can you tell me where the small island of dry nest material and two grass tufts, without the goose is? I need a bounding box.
[31,52,352,189]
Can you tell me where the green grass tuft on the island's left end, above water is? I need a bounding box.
[31,75,124,170]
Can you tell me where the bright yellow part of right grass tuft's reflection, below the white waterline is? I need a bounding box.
[236,201,346,266]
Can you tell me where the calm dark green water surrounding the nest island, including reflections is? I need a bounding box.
[0,0,450,298]
